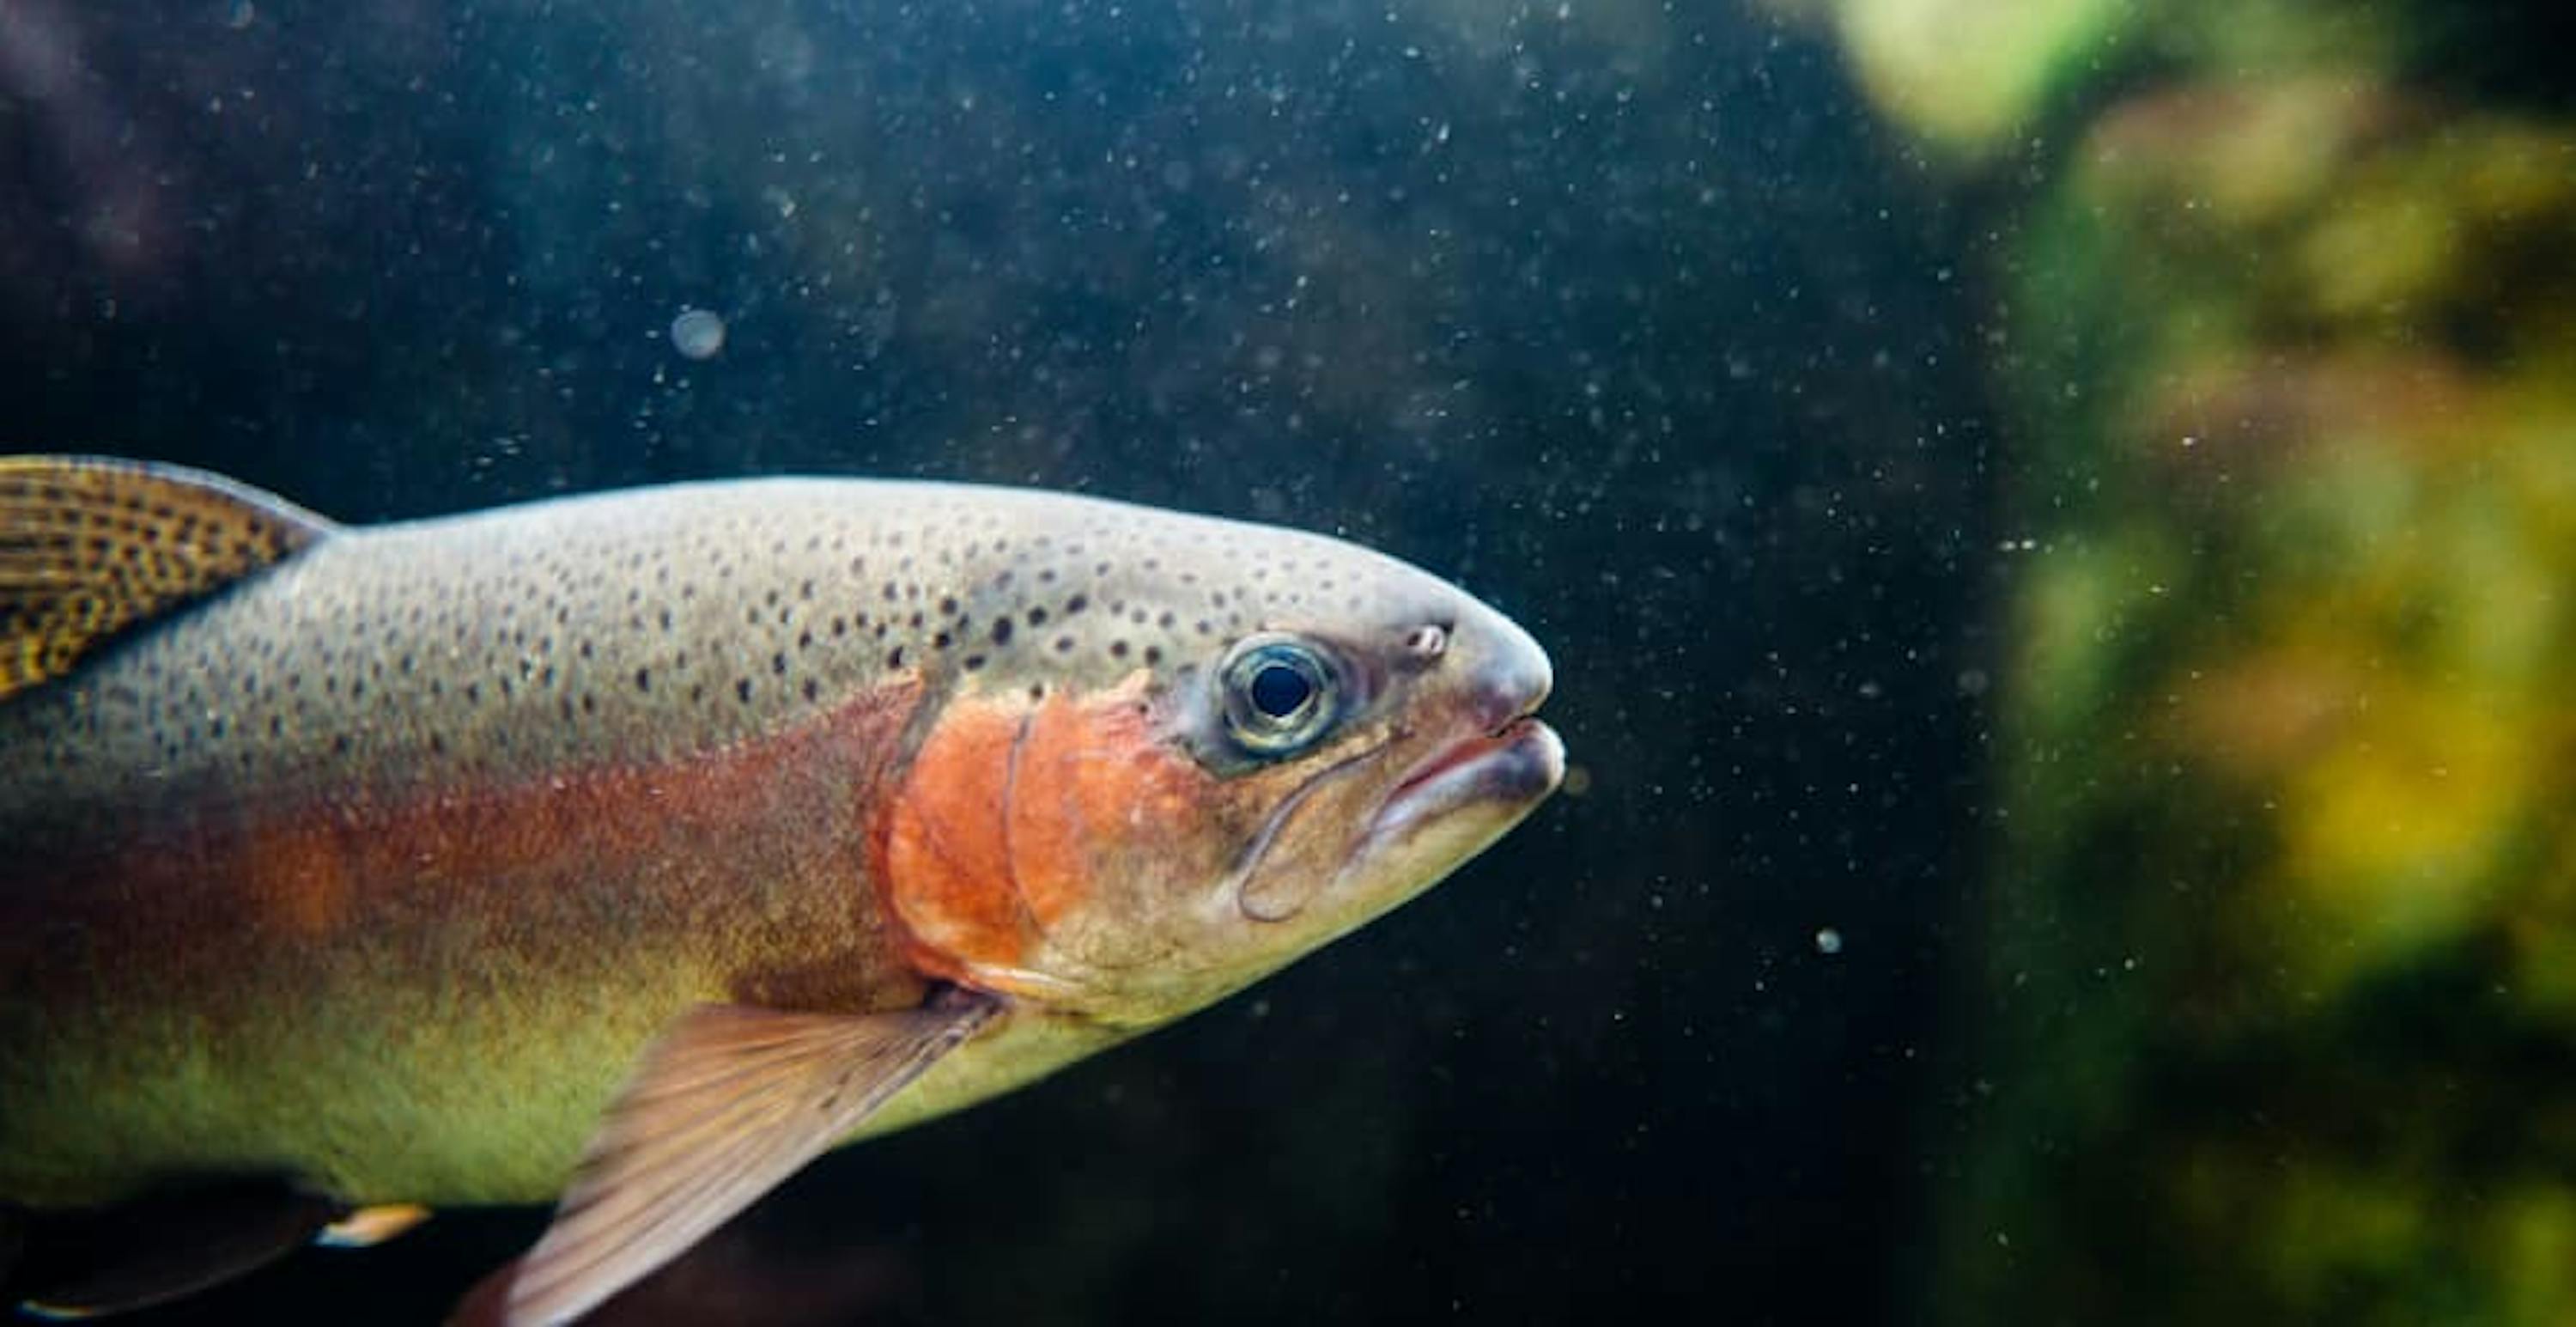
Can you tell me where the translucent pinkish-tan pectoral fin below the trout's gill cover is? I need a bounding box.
[507,989,1002,1327]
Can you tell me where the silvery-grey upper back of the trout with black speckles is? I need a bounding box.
[0,479,1463,830]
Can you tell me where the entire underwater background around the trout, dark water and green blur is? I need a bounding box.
[0,0,2576,1324]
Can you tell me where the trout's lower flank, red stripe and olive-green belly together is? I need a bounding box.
[0,696,927,1203]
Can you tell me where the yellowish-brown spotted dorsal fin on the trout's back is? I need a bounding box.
[0,456,332,698]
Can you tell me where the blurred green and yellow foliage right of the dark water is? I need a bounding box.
[1783,0,2576,1327]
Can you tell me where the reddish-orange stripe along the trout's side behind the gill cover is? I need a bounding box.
[0,678,920,1018]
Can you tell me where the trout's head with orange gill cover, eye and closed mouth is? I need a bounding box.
[881,508,1564,1026]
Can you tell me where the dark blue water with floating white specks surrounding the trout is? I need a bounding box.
[0,0,1991,1324]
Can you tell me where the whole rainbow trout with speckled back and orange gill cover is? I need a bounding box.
[0,456,1564,1324]
